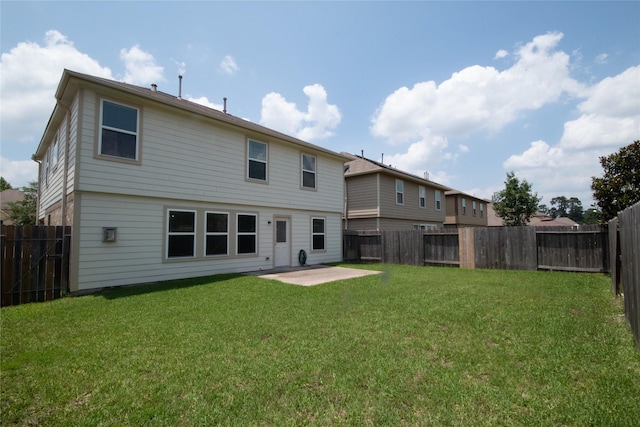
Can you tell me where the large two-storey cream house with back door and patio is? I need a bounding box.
[34,70,347,292]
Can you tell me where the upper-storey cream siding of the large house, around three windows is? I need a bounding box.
[78,90,343,212]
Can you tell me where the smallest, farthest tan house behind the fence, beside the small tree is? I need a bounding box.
[444,190,488,228]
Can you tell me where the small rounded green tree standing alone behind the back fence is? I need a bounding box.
[492,172,540,226]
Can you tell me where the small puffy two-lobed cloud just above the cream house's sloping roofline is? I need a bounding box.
[260,84,341,141]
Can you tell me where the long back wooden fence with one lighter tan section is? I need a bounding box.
[343,226,609,272]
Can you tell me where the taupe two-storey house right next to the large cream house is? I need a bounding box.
[342,153,449,230]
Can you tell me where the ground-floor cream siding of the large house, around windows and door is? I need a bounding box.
[71,192,342,291]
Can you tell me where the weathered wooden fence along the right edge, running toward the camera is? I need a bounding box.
[609,202,640,351]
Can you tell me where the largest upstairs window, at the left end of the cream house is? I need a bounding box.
[99,99,139,160]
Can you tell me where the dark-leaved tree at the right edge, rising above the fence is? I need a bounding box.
[591,140,640,221]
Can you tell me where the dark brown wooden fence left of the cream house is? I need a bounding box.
[0,225,71,307]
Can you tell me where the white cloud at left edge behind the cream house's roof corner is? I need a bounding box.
[0,30,113,144]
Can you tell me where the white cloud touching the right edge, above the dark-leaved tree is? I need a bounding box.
[503,66,640,206]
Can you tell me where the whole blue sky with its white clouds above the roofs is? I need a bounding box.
[0,1,640,208]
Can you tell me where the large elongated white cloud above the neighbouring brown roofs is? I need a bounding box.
[371,33,584,173]
